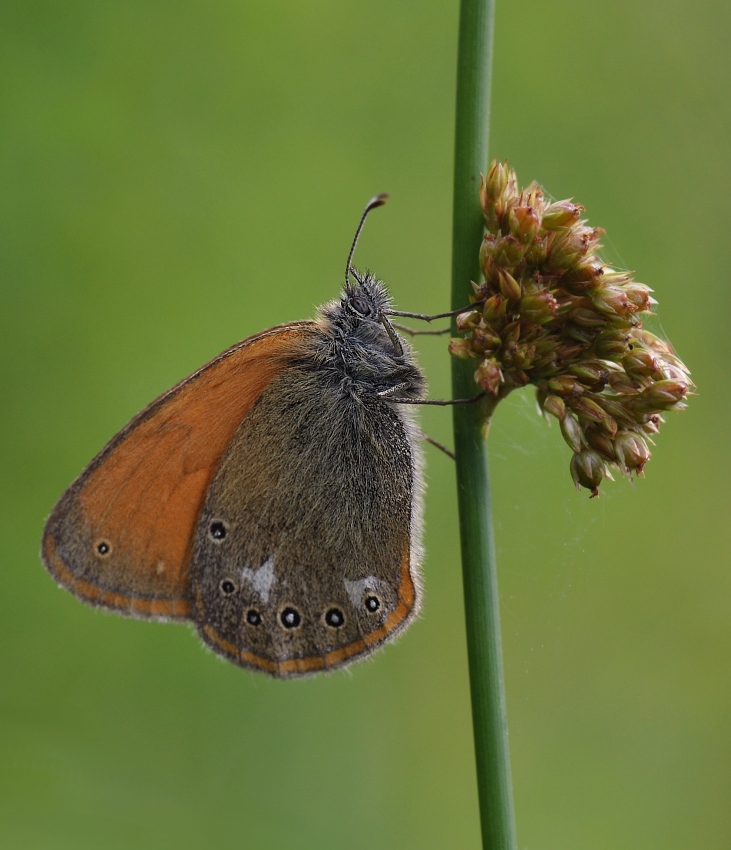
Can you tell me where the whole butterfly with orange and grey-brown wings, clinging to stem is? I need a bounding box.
[41,195,447,678]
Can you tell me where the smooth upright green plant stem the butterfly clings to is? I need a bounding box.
[452,0,516,850]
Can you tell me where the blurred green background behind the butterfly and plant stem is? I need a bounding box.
[0,0,731,850]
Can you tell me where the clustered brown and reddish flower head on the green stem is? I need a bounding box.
[450,160,693,496]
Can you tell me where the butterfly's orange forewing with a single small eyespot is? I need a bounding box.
[41,322,317,619]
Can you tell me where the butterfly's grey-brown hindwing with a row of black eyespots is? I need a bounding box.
[191,358,418,677]
